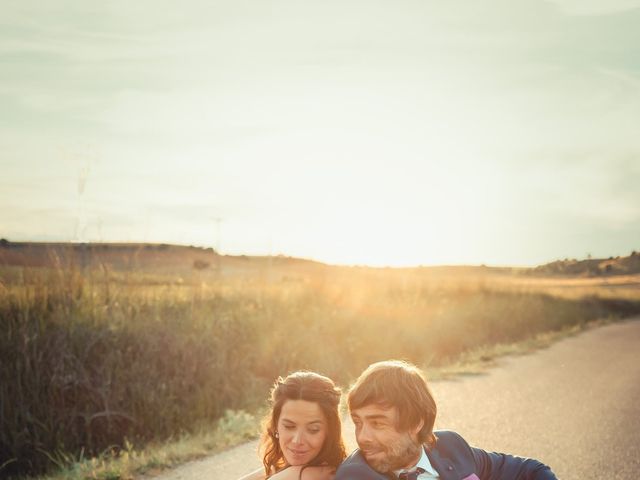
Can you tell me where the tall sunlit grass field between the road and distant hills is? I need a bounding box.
[0,264,640,475]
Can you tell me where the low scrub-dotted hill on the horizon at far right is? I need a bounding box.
[528,251,640,277]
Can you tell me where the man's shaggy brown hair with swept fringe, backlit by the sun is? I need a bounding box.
[348,360,437,448]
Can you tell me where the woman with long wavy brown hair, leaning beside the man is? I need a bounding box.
[240,372,346,480]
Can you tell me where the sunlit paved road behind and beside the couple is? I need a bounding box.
[152,321,640,480]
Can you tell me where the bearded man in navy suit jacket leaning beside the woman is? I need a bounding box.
[335,360,556,480]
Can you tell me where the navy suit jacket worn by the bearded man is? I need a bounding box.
[335,430,557,480]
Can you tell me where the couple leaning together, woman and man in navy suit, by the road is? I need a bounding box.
[241,360,556,480]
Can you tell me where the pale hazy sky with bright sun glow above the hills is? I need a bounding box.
[0,0,640,266]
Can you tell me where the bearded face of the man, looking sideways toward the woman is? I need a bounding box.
[351,404,422,473]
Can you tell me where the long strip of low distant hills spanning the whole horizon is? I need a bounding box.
[0,238,640,277]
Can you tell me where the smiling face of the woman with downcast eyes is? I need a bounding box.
[278,400,328,465]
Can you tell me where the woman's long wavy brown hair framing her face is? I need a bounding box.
[260,372,347,477]
